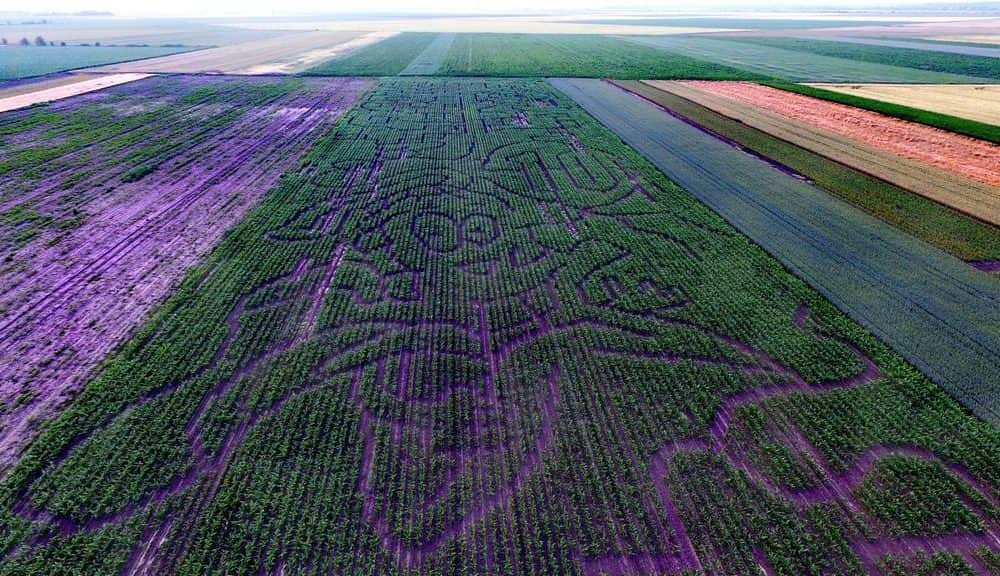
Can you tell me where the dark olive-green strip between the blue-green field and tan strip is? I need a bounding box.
[617,81,1000,260]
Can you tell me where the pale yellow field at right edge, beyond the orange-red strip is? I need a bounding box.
[812,84,1000,126]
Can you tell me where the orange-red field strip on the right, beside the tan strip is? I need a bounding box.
[687,81,1000,186]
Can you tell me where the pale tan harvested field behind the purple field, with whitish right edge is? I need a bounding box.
[95,31,368,74]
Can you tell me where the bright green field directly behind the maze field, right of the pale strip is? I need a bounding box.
[438,34,761,80]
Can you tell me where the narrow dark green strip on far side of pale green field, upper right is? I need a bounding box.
[733,36,1000,80]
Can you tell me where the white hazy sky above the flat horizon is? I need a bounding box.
[13,0,984,16]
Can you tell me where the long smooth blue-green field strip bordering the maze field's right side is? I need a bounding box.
[552,80,1000,424]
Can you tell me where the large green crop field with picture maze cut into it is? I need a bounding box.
[0,80,1000,575]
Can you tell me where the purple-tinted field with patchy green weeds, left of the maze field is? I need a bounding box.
[0,77,370,470]
